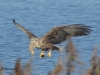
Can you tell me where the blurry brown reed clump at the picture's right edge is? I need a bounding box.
[87,46,100,75]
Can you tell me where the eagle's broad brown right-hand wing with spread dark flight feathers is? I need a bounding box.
[43,24,91,44]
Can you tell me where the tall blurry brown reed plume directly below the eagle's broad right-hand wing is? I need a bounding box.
[66,38,78,75]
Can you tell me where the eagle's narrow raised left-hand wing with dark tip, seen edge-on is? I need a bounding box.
[13,19,37,39]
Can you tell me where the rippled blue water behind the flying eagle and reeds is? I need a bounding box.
[0,0,100,75]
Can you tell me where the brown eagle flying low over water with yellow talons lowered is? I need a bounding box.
[12,19,91,58]
